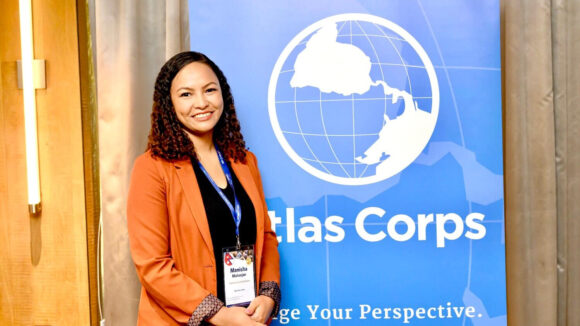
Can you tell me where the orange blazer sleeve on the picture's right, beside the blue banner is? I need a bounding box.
[248,152,281,316]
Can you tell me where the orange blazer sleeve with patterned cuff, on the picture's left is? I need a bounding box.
[127,153,223,325]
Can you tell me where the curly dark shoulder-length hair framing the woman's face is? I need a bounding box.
[147,51,246,162]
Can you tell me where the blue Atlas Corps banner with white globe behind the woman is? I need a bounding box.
[189,0,507,326]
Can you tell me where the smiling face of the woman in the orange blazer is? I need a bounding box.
[170,62,224,138]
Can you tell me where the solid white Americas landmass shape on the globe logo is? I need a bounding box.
[290,23,432,174]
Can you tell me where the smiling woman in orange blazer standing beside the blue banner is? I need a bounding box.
[127,52,280,325]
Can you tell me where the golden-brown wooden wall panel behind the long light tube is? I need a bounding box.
[0,0,94,325]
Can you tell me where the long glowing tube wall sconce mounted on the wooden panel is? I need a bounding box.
[19,0,46,215]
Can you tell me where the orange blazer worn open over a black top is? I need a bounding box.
[127,151,280,326]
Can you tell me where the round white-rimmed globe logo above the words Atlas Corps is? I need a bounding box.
[268,14,439,185]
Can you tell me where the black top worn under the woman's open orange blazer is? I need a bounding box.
[192,160,256,302]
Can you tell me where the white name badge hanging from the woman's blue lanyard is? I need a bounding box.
[222,246,256,307]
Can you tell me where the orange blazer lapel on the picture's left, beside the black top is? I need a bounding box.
[174,160,215,263]
